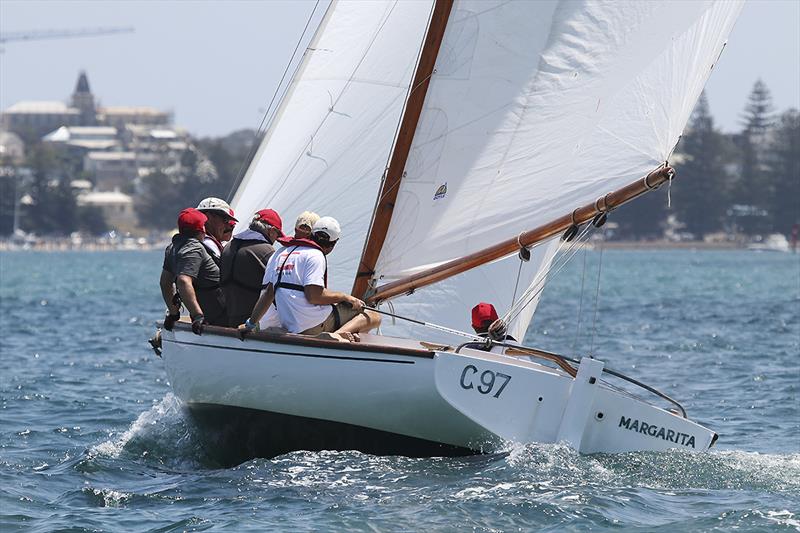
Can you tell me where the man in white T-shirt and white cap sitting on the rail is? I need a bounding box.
[240,217,380,340]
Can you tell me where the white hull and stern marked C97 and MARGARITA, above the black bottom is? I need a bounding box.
[162,324,716,453]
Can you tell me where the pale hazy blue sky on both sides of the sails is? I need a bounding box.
[0,0,800,135]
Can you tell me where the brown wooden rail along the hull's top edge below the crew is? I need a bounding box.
[174,321,434,359]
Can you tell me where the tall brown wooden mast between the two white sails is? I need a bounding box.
[352,0,453,298]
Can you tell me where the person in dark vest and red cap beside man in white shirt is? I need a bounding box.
[219,209,283,327]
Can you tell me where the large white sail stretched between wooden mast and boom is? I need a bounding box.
[376,0,741,284]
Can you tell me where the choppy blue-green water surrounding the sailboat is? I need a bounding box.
[0,251,800,532]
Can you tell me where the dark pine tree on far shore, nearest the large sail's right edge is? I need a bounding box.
[673,94,727,238]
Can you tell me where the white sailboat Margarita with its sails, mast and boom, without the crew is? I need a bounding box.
[155,0,741,455]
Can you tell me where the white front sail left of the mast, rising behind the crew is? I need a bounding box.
[232,1,431,292]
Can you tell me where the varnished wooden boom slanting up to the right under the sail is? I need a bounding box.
[366,166,674,305]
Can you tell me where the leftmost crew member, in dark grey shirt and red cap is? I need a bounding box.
[160,207,227,335]
